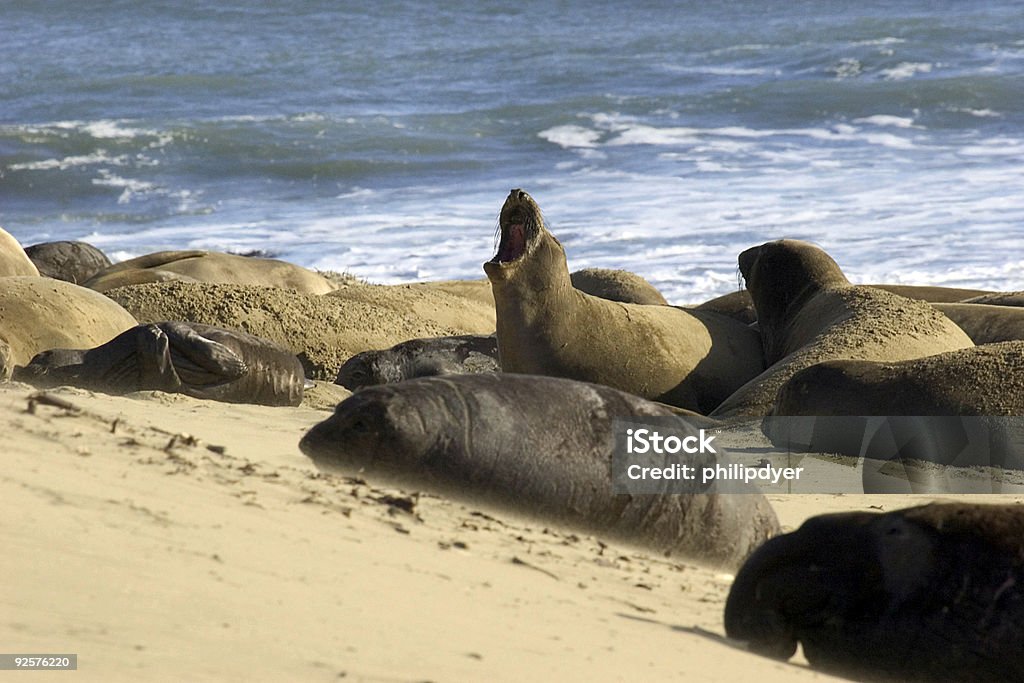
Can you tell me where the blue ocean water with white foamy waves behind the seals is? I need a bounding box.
[0,0,1024,303]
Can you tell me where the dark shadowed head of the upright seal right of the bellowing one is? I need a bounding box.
[739,240,850,331]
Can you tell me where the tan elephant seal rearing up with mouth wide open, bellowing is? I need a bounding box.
[483,189,764,413]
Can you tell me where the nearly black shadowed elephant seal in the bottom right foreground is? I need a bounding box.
[725,503,1024,682]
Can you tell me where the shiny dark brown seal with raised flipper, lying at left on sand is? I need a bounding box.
[14,322,306,405]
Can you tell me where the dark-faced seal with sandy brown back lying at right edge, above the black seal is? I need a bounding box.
[763,341,1024,493]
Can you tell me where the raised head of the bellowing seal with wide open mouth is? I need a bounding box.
[483,188,568,283]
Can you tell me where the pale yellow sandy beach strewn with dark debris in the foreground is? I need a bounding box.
[0,383,1024,681]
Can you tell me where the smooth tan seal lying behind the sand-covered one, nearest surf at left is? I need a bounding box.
[85,250,337,294]
